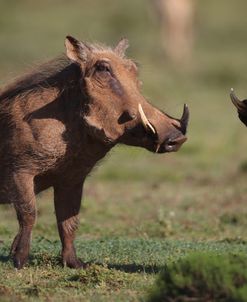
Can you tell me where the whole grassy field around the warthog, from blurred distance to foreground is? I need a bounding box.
[0,0,247,301]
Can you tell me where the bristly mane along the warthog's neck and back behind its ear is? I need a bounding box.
[0,55,81,104]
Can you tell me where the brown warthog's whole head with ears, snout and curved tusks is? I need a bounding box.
[65,36,189,153]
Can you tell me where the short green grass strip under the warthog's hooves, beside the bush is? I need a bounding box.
[0,237,247,301]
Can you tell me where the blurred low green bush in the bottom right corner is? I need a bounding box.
[148,252,247,302]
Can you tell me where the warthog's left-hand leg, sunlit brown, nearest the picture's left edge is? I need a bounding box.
[10,174,36,269]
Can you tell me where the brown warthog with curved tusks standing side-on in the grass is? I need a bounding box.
[0,36,189,269]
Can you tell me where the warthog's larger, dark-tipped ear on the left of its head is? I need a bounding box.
[65,36,91,64]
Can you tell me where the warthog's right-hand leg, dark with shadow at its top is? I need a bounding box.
[54,183,83,268]
